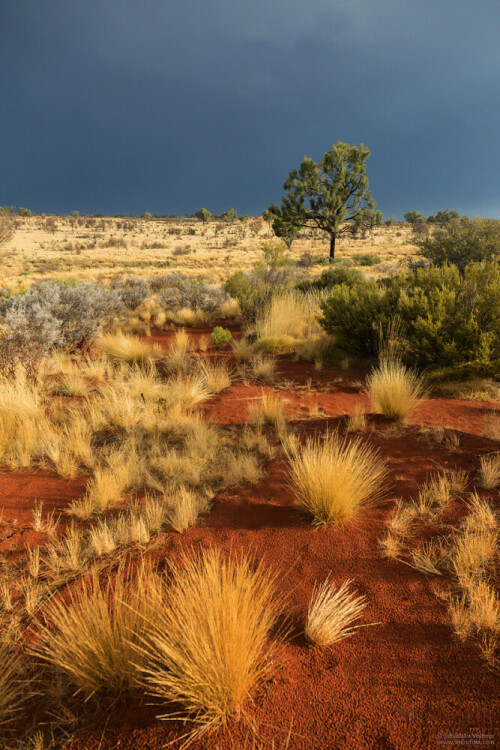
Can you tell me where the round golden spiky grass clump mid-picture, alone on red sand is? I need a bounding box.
[289,433,387,526]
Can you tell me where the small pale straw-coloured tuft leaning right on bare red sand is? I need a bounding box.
[305,578,367,646]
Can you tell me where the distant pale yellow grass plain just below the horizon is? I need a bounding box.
[2,216,415,290]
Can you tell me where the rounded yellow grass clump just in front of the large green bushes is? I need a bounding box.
[367,360,424,420]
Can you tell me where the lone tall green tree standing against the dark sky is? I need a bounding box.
[268,141,382,260]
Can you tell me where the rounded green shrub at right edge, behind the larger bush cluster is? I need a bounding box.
[414,216,500,271]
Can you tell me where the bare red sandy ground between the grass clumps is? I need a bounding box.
[0,331,500,750]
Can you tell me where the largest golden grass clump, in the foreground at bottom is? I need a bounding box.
[141,549,279,731]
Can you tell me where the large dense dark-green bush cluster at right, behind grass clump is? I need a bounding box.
[320,261,500,373]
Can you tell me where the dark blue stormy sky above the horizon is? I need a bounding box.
[0,0,500,218]
